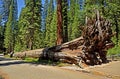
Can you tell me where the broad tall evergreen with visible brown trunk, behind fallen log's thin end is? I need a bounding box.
[16,0,42,51]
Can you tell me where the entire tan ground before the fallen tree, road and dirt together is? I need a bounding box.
[0,55,120,79]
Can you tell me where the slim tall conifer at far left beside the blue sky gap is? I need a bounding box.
[4,0,17,52]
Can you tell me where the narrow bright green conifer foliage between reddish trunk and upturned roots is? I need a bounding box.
[68,0,84,40]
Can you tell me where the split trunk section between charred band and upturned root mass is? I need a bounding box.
[40,37,84,64]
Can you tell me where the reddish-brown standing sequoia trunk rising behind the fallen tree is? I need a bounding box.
[57,0,63,45]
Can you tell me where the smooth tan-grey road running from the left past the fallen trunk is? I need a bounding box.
[0,54,120,79]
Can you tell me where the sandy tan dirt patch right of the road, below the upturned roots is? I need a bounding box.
[88,61,120,79]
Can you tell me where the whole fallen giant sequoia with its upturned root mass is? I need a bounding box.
[15,12,114,66]
